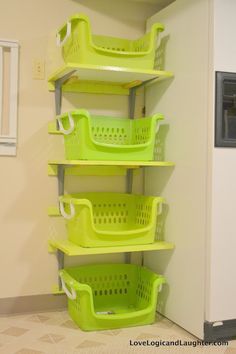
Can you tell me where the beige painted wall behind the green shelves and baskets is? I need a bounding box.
[0,0,155,298]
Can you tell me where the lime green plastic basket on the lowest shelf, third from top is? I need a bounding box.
[59,193,164,247]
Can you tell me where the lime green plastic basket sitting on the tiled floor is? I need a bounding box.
[59,264,165,331]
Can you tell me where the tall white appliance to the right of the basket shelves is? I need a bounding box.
[144,0,236,340]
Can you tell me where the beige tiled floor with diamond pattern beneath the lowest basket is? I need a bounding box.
[0,311,236,354]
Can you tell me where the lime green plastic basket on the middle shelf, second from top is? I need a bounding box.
[57,110,164,161]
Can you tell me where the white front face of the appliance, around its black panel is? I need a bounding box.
[206,0,236,321]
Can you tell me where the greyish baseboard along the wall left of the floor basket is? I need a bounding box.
[0,294,67,316]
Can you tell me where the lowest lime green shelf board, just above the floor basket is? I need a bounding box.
[49,240,174,256]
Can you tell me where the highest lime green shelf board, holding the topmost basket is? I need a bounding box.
[48,63,173,95]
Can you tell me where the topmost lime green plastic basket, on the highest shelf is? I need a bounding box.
[57,14,164,69]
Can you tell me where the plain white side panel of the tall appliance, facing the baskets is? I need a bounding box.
[145,0,209,338]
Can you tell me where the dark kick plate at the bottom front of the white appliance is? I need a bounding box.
[204,319,236,341]
